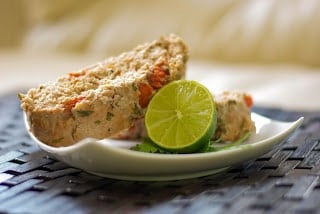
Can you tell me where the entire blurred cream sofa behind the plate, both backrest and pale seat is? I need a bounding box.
[0,0,320,110]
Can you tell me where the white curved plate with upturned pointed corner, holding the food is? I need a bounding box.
[26,113,303,181]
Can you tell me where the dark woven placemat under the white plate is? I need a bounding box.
[0,94,320,214]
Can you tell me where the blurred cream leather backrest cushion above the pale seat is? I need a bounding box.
[18,0,320,66]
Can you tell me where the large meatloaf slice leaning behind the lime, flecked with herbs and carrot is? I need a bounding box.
[19,34,188,147]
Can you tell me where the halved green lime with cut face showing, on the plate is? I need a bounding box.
[145,80,217,153]
